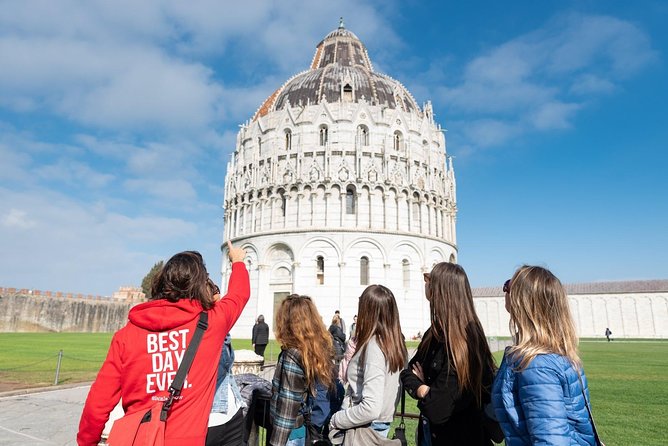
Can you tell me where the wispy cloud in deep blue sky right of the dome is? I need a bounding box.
[434,14,656,152]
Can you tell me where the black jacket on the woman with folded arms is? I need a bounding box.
[401,333,494,446]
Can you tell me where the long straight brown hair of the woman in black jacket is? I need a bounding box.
[418,262,496,406]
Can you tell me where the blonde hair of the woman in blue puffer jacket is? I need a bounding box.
[506,265,581,370]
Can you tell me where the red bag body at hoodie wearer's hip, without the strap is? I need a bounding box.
[107,403,165,446]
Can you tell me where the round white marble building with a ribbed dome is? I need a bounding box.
[222,22,457,338]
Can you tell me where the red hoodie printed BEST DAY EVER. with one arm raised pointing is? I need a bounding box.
[77,262,250,446]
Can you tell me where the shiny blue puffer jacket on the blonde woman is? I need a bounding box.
[492,354,595,446]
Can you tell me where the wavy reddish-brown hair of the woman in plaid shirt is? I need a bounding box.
[274,294,334,393]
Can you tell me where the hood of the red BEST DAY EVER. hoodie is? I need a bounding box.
[128,299,202,331]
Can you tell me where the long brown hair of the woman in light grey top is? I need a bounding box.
[355,285,408,373]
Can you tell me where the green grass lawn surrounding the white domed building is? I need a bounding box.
[0,333,668,446]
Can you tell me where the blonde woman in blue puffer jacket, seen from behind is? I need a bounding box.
[492,265,597,446]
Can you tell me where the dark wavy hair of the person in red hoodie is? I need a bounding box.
[151,251,220,310]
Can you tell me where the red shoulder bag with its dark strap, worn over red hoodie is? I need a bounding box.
[107,311,209,446]
